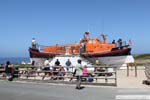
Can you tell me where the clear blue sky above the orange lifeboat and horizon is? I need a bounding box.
[0,0,150,57]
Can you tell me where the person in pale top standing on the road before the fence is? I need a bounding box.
[75,59,83,89]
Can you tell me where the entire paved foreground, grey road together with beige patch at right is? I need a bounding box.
[0,69,150,100]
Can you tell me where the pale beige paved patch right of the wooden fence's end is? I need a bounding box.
[117,69,150,89]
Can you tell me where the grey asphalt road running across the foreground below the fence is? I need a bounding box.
[0,81,150,100]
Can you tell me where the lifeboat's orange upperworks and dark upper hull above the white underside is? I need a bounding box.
[29,32,131,58]
